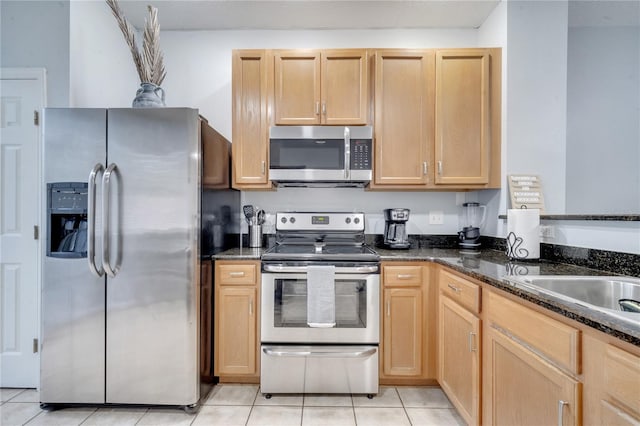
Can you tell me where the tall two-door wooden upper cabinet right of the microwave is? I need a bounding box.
[370,48,502,190]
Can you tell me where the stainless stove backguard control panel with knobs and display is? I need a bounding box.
[276,212,364,232]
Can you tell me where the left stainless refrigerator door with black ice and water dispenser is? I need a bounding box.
[40,108,107,403]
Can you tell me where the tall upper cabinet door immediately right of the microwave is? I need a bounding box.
[372,50,434,188]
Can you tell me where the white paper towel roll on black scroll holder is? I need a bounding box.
[507,209,540,259]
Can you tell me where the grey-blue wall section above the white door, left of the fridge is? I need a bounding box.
[0,0,69,107]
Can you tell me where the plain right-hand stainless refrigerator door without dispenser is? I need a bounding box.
[105,108,200,405]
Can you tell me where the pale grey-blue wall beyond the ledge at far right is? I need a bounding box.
[566,26,640,214]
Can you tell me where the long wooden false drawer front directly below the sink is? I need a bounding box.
[485,292,580,374]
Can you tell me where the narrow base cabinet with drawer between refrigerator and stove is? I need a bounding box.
[214,261,260,383]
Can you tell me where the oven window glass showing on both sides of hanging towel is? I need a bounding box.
[273,279,367,328]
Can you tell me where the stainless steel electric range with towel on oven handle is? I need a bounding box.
[260,212,380,398]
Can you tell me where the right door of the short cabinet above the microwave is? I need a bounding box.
[320,50,369,125]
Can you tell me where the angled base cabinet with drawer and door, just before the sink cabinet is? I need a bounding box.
[438,269,482,425]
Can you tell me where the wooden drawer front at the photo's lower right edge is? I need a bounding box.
[604,345,640,415]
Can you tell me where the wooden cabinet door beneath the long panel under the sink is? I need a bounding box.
[483,327,581,425]
